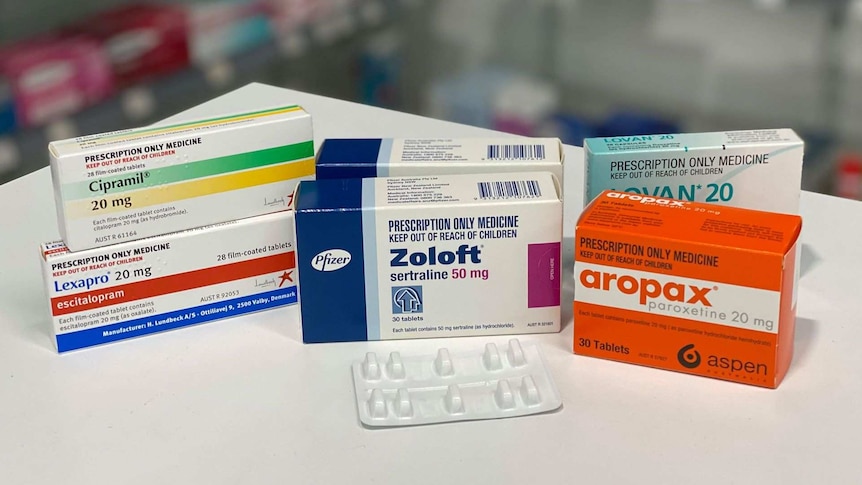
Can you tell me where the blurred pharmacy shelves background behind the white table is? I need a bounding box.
[0,0,862,199]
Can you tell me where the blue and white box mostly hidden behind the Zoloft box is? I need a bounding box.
[317,137,563,183]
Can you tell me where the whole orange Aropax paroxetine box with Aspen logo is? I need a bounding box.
[573,191,802,388]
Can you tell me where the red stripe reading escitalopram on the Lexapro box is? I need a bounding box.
[51,251,296,316]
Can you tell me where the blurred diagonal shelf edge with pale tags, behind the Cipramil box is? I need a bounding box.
[0,0,422,184]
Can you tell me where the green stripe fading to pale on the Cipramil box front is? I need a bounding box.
[62,141,314,200]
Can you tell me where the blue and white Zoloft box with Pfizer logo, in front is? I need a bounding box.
[296,172,562,342]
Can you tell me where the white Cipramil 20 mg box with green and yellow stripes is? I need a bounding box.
[49,106,314,251]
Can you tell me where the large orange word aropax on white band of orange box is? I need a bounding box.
[580,269,714,307]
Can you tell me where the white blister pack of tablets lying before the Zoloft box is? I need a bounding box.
[353,339,562,427]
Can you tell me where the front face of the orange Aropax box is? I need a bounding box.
[573,230,792,387]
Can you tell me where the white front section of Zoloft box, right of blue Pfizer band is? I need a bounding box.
[366,199,561,339]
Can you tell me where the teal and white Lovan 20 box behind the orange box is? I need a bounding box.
[584,129,804,214]
